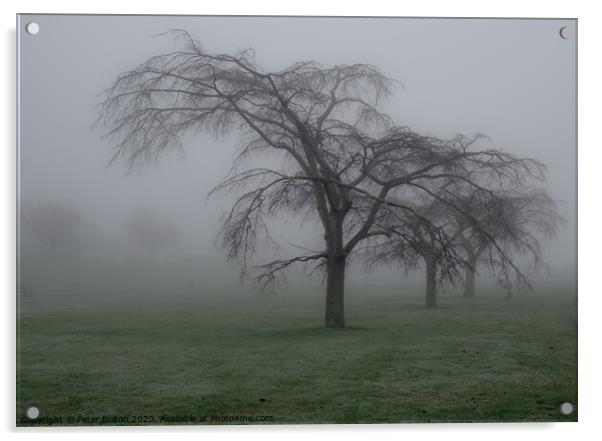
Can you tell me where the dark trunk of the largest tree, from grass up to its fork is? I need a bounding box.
[325,216,347,328]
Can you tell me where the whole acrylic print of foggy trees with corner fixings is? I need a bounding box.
[16,15,578,426]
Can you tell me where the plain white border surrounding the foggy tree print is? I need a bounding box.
[0,0,602,441]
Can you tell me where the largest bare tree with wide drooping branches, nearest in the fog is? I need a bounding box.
[98,31,539,327]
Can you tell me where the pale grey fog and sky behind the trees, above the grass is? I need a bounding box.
[17,15,576,304]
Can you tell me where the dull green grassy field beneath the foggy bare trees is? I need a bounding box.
[17,292,577,425]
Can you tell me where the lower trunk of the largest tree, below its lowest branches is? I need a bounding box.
[325,256,346,328]
